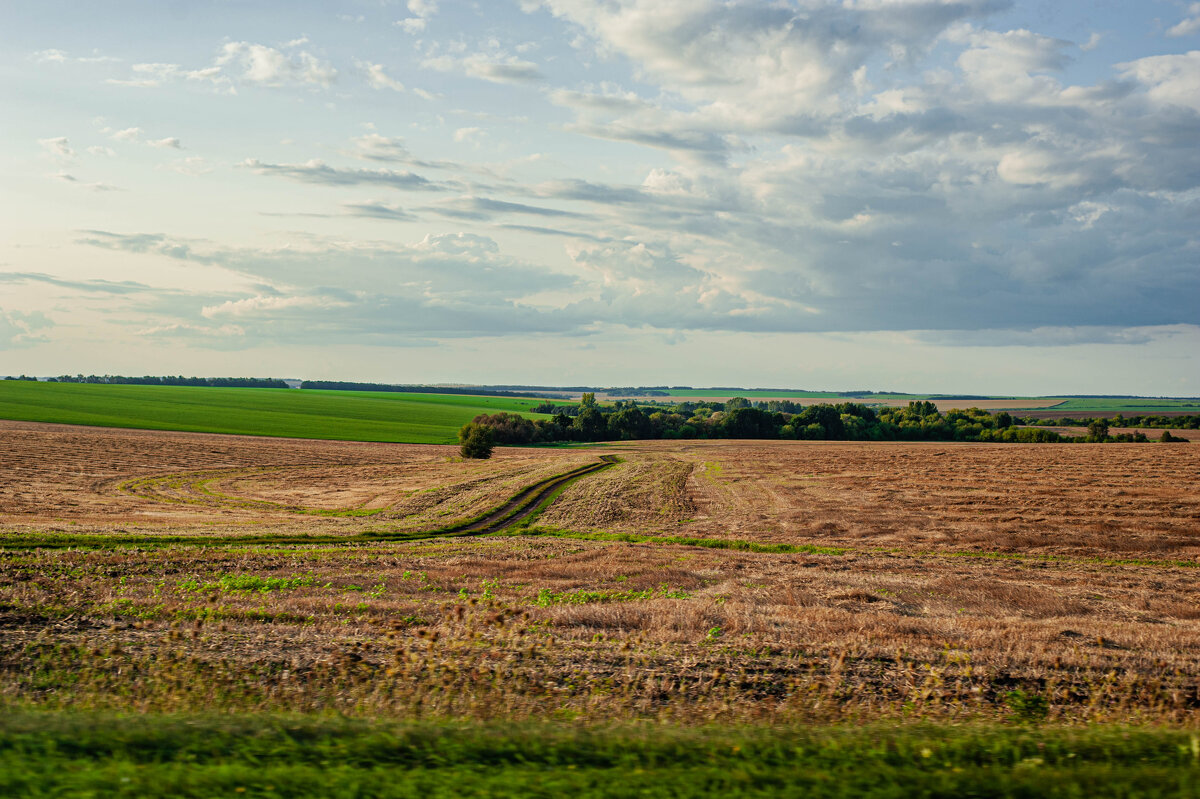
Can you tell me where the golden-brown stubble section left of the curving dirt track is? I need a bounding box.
[0,421,595,534]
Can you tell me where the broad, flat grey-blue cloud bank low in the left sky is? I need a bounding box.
[72,230,586,348]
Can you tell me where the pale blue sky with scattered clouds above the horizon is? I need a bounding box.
[0,0,1200,396]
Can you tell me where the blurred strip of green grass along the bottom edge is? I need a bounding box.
[0,711,1200,798]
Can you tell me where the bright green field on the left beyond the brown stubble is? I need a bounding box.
[0,380,566,444]
